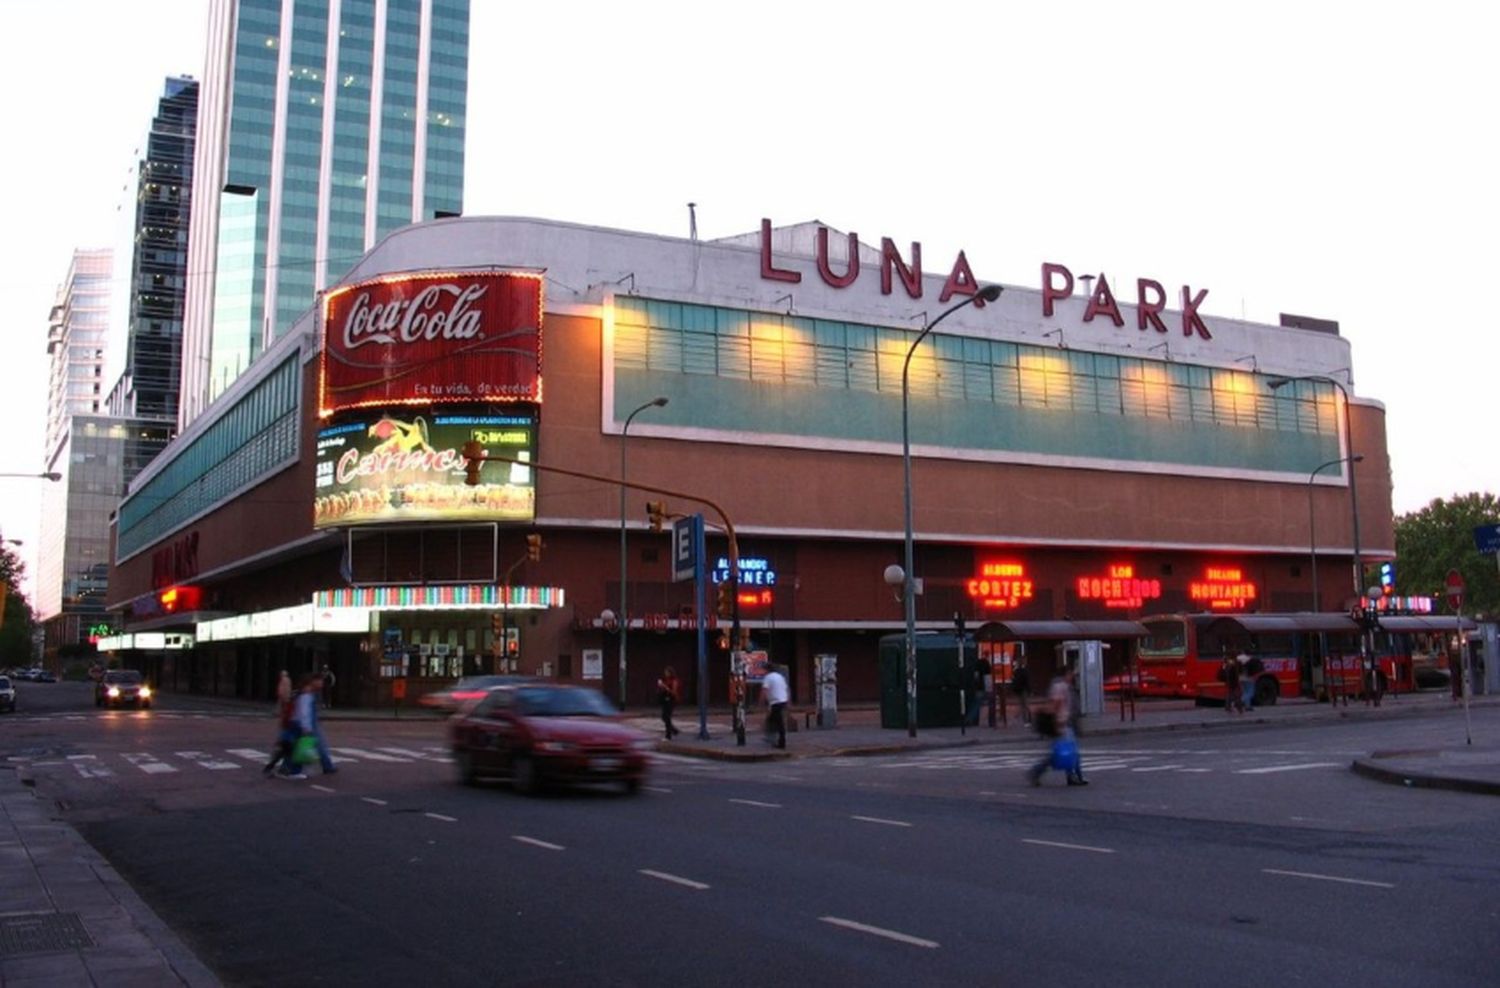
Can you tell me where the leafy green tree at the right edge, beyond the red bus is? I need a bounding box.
[1397,493,1500,616]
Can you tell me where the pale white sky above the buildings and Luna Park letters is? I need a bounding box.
[0,0,1500,596]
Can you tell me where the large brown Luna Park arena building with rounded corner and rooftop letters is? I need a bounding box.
[108,217,1394,703]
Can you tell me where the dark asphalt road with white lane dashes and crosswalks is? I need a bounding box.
[0,684,1500,987]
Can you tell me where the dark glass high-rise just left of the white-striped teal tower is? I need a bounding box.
[108,76,198,425]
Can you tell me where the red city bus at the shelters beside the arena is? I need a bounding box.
[1128,613,1428,706]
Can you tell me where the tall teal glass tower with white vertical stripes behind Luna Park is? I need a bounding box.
[179,0,470,427]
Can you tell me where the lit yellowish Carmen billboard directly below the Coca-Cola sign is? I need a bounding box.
[312,408,537,528]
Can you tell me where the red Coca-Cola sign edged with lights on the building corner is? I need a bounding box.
[318,271,542,417]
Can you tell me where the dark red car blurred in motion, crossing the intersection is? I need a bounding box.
[450,682,656,793]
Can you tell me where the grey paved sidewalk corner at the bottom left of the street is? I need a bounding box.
[0,768,219,988]
